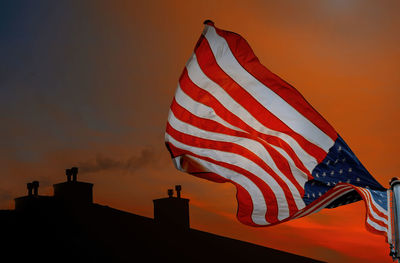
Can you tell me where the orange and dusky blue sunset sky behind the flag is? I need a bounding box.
[0,0,400,262]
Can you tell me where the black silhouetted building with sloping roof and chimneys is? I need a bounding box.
[0,168,319,262]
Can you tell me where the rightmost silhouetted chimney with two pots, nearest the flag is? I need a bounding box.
[153,185,190,230]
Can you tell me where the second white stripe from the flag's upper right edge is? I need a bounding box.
[186,54,318,172]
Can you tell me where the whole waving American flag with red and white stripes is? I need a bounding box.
[165,20,391,237]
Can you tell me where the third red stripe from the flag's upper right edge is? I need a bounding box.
[179,68,313,180]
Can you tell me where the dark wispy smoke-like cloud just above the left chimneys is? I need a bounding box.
[78,149,158,173]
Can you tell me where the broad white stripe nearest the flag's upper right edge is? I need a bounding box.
[203,25,334,152]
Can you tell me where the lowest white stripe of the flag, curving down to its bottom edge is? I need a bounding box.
[169,140,269,225]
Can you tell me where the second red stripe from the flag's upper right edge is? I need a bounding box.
[195,36,327,163]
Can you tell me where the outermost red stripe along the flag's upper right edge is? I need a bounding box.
[214,27,338,141]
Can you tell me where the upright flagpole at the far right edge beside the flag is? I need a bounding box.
[388,177,400,262]
